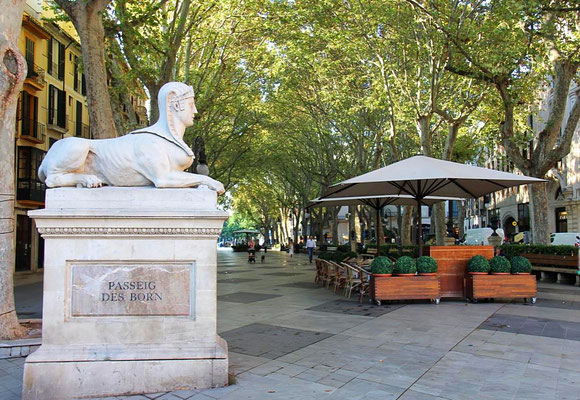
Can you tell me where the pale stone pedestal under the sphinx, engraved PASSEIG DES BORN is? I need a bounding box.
[23,187,228,400]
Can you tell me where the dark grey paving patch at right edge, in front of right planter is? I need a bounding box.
[480,314,580,341]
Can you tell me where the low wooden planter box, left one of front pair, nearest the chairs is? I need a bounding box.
[371,275,441,305]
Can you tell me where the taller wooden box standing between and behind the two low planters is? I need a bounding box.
[429,246,493,298]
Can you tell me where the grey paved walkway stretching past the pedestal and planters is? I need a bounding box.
[6,251,580,400]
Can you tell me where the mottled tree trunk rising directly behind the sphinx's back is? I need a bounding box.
[55,0,117,139]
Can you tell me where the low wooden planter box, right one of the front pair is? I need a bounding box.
[465,275,538,303]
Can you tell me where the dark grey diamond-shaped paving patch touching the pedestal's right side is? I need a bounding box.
[221,324,331,359]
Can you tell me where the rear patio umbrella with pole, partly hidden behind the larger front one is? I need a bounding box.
[306,195,462,255]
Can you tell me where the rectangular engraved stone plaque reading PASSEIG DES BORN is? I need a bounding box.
[71,263,194,317]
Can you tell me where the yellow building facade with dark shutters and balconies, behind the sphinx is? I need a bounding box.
[14,0,91,273]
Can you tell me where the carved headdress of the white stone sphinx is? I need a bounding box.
[131,82,194,156]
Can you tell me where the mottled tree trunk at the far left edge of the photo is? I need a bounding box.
[0,0,27,339]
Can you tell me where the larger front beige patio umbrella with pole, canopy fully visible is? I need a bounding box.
[320,156,545,254]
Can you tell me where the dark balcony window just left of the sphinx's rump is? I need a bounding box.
[16,146,45,202]
